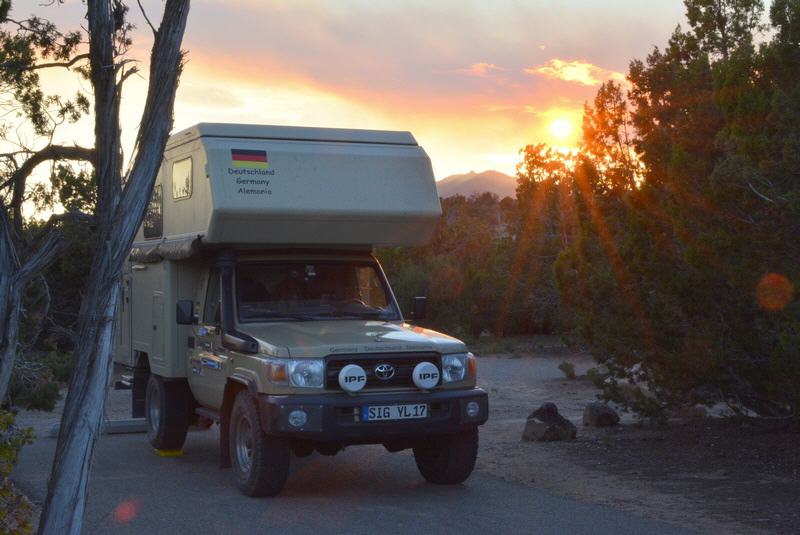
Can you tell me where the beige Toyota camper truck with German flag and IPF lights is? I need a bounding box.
[114,124,489,496]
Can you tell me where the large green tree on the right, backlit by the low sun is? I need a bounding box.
[552,0,800,420]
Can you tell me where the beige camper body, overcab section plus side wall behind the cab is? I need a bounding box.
[114,123,441,377]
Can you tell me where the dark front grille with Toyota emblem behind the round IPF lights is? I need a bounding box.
[325,353,442,390]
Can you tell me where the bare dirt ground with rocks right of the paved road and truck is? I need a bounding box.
[476,339,800,533]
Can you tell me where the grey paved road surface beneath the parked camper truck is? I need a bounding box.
[13,420,687,535]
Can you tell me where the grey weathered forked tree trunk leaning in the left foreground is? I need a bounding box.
[39,0,189,535]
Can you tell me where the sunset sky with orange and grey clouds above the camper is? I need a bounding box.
[28,0,683,179]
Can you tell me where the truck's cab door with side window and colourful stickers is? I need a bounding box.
[193,268,228,409]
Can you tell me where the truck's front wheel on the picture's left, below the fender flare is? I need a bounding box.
[228,390,291,497]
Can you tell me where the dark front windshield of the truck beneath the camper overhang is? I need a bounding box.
[236,261,400,322]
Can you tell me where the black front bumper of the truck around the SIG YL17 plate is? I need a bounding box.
[258,388,489,445]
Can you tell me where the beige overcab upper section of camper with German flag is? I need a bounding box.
[134,123,441,258]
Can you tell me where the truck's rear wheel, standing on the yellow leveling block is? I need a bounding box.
[145,374,191,450]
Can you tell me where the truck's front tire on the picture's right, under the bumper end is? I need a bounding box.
[414,427,478,485]
